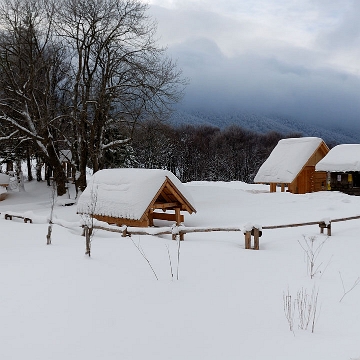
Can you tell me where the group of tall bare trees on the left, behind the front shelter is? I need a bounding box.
[0,0,185,195]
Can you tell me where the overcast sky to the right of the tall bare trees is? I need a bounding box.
[148,0,360,129]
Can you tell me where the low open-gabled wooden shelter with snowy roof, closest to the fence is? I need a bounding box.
[77,169,196,227]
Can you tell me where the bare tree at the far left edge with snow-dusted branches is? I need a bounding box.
[0,0,70,195]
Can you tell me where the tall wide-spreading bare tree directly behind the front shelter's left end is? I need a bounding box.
[57,0,184,190]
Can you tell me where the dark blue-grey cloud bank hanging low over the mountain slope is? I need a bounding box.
[170,40,360,129]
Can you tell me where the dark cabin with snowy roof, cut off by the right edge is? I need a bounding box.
[315,144,360,195]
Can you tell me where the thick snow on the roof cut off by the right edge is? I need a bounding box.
[315,144,360,172]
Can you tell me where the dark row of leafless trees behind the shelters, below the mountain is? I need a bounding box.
[125,121,300,183]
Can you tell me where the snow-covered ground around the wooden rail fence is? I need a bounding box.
[0,182,360,360]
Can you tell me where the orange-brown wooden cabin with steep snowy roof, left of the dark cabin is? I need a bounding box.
[254,137,329,194]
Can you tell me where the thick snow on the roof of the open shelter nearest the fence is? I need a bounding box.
[77,168,193,220]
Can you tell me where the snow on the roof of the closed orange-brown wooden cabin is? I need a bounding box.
[254,137,323,184]
